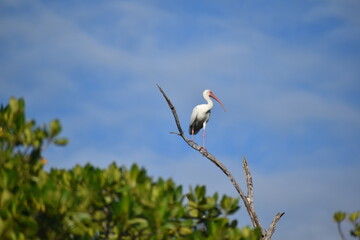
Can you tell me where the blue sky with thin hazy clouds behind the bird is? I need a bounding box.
[0,0,360,240]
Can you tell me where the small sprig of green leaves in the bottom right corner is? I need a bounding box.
[333,211,360,239]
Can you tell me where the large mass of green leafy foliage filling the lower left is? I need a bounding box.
[0,98,260,240]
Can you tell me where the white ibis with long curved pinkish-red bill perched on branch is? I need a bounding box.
[189,90,226,149]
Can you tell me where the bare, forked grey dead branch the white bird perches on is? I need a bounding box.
[157,85,284,240]
